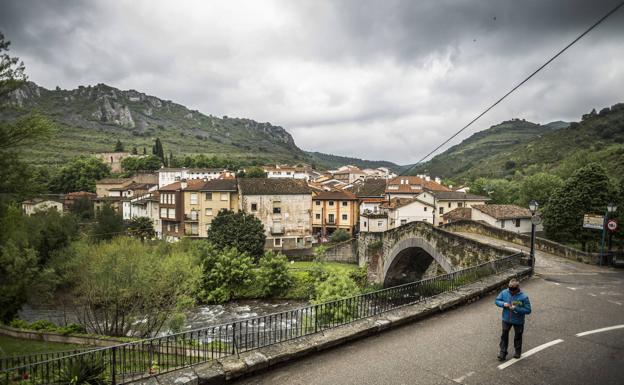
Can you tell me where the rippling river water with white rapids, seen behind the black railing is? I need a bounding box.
[18,300,307,332]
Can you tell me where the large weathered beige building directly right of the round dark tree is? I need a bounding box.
[238,178,312,251]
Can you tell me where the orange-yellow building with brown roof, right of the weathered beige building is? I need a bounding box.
[312,191,359,240]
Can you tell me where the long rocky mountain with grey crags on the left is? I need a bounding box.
[0,82,306,164]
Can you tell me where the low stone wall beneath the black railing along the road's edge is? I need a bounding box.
[132,267,531,385]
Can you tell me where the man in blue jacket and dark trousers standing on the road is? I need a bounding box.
[495,279,531,361]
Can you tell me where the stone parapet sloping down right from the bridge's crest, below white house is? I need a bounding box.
[441,220,600,265]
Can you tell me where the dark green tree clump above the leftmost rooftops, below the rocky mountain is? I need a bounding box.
[50,156,110,193]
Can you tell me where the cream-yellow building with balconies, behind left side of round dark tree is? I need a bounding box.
[183,179,238,238]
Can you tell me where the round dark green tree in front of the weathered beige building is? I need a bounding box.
[208,210,266,259]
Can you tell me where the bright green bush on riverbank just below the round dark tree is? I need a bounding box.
[196,242,253,303]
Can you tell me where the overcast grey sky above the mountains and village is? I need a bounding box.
[0,0,624,164]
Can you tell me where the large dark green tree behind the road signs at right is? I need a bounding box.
[543,163,616,250]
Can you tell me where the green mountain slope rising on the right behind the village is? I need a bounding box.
[412,103,624,182]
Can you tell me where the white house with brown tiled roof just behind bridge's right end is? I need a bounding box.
[471,205,543,233]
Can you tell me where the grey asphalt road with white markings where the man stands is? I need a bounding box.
[230,236,624,385]
